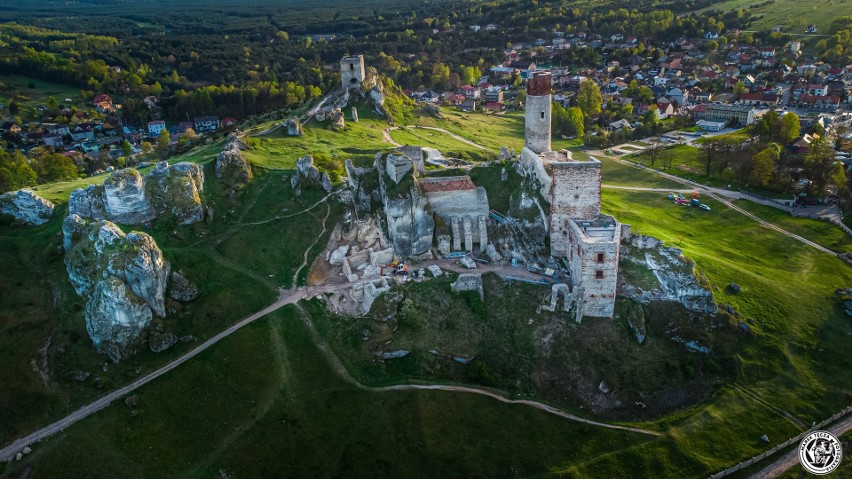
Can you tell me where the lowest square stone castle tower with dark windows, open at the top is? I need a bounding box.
[567,220,621,320]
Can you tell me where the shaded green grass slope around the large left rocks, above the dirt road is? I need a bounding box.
[0,164,342,450]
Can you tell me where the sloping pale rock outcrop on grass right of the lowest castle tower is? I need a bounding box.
[618,235,718,314]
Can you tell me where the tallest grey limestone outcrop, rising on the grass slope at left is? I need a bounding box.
[62,214,176,362]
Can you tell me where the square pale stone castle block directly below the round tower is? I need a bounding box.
[550,158,601,256]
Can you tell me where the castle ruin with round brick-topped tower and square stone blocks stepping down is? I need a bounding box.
[521,73,622,321]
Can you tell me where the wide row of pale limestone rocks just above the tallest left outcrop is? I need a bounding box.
[68,161,204,225]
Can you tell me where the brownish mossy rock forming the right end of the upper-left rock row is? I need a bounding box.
[147,161,204,225]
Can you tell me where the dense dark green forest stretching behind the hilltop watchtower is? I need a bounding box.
[0,0,749,124]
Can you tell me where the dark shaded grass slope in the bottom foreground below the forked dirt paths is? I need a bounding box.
[0,307,653,478]
